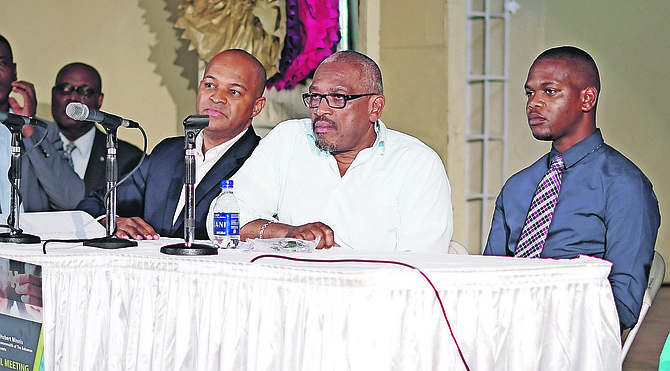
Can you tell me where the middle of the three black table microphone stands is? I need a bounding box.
[84,125,137,249]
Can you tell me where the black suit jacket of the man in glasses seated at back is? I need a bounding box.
[84,127,142,194]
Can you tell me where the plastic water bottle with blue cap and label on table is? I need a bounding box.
[212,179,240,249]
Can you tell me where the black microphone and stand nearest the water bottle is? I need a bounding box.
[161,115,219,256]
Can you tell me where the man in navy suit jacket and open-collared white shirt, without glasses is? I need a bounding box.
[77,49,266,239]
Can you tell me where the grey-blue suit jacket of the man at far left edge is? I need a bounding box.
[20,122,86,211]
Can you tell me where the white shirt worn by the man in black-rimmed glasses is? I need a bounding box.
[227,119,453,253]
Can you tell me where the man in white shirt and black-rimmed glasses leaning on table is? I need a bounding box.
[223,51,453,252]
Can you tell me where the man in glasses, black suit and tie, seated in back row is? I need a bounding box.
[49,62,142,194]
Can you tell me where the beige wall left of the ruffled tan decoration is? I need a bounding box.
[0,0,197,149]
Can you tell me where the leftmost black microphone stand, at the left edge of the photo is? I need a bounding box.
[0,126,40,243]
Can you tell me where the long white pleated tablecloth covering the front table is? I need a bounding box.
[0,239,621,371]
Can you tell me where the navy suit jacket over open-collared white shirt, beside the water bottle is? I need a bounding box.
[77,127,260,240]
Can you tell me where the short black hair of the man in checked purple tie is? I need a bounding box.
[531,46,600,92]
